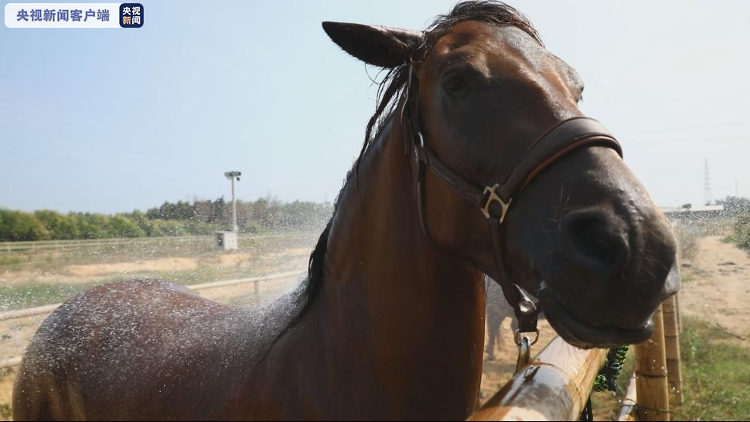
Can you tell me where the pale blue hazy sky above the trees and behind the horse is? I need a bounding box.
[0,0,750,212]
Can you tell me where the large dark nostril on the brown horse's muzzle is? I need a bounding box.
[562,209,630,273]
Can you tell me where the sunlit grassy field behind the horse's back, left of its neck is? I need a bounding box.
[0,232,318,312]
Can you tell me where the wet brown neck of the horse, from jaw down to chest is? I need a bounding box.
[315,117,485,417]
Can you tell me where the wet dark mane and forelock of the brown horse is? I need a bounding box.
[300,0,542,316]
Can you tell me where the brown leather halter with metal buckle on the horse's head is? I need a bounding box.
[401,64,622,337]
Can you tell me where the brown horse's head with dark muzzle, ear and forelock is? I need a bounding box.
[323,2,679,347]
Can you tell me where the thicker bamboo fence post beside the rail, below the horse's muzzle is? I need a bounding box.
[635,305,669,421]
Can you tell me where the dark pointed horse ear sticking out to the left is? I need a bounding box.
[323,22,422,68]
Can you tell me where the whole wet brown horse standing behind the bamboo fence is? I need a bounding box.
[13,1,677,420]
